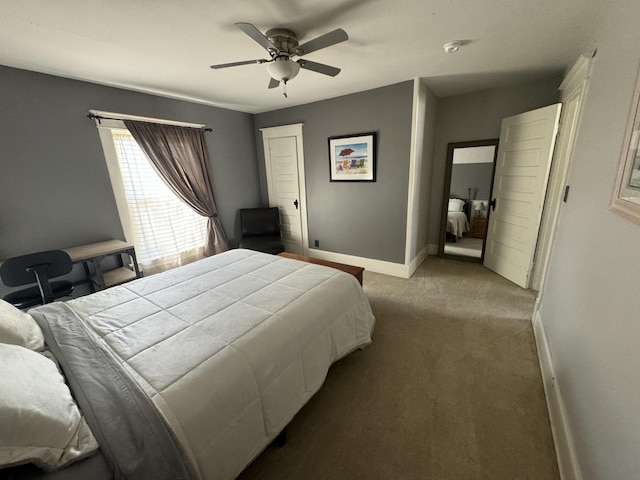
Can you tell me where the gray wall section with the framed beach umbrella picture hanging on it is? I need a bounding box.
[255,82,413,263]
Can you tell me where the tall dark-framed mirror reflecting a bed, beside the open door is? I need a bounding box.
[439,139,498,262]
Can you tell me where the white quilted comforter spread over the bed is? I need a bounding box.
[62,250,375,480]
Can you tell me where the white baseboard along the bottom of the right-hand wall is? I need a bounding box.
[532,304,582,480]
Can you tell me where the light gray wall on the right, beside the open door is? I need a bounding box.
[540,0,640,480]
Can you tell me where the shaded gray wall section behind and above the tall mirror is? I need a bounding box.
[429,76,562,244]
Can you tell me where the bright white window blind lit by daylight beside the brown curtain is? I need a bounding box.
[112,130,207,274]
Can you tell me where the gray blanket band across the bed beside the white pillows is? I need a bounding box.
[4,302,189,480]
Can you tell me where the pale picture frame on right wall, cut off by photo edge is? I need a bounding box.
[609,62,640,224]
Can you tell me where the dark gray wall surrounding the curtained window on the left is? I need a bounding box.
[0,66,260,288]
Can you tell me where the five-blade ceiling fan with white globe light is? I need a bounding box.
[211,22,349,97]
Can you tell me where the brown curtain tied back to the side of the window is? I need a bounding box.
[124,120,229,255]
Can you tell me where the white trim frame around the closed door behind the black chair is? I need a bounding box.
[260,123,309,255]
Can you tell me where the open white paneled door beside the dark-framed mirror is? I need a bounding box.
[484,103,562,288]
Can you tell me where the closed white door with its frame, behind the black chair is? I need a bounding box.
[261,125,308,255]
